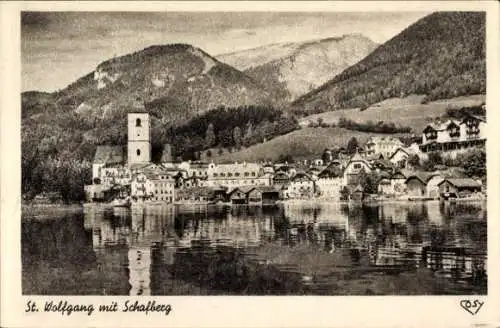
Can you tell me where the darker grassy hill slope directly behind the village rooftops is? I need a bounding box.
[213,127,410,162]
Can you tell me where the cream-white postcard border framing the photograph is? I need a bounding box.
[0,1,500,327]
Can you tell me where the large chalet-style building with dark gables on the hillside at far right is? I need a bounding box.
[420,115,486,156]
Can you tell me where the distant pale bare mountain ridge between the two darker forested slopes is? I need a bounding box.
[217,34,378,106]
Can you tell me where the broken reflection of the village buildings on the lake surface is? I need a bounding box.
[85,202,486,295]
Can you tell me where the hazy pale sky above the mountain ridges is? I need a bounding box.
[21,12,429,92]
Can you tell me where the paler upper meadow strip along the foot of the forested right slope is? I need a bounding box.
[299,95,485,134]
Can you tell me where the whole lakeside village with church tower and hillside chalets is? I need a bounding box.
[85,105,486,206]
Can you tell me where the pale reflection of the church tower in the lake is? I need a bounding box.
[128,247,151,295]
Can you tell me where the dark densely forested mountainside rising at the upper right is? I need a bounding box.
[293,12,486,112]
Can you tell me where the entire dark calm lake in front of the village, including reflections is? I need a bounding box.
[22,202,487,295]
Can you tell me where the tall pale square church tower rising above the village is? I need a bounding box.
[127,101,151,166]
